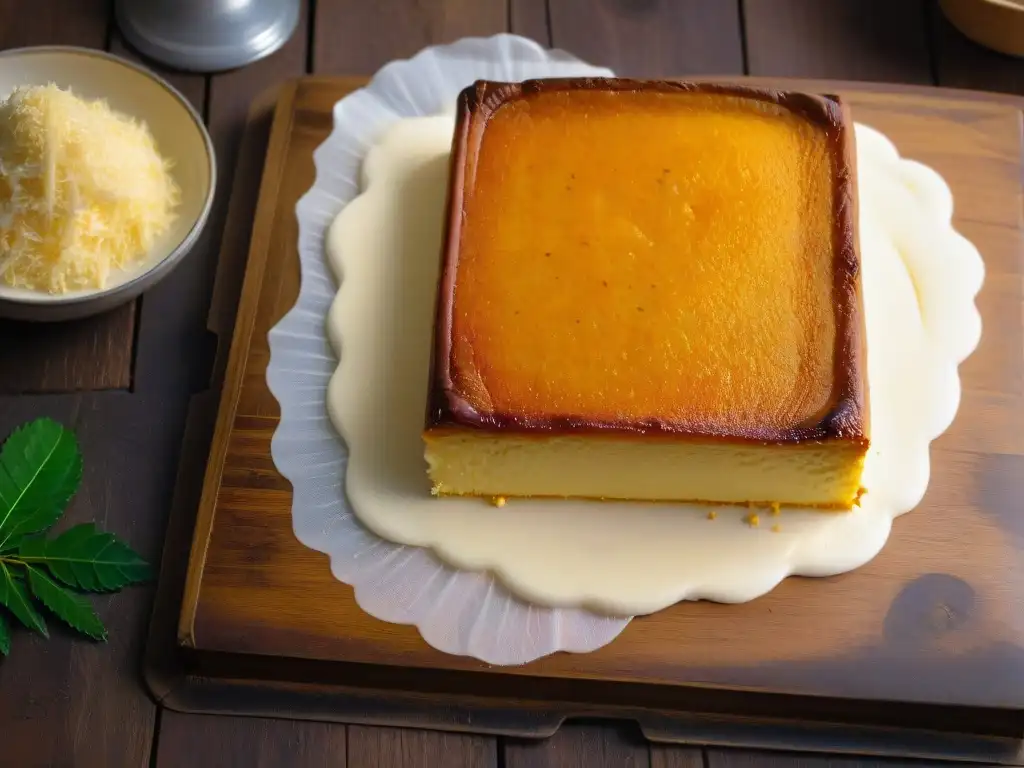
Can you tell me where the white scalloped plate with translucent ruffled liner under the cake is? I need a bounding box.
[267,36,983,664]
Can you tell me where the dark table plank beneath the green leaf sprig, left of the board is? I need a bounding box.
[0,392,183,768]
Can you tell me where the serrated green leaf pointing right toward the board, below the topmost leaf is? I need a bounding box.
[18,523,153,592]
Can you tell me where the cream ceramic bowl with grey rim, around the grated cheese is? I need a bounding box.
[0,46,217,321]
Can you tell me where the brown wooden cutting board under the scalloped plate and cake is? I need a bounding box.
[151,78,1024,763]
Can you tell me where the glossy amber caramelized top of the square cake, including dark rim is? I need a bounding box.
[431,80,866,440]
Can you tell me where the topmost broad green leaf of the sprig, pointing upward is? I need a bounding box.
[0,419,82,552]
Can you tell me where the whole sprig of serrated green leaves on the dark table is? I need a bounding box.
[0,419,152,655]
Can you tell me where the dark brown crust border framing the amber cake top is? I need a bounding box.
[424,78,869,449]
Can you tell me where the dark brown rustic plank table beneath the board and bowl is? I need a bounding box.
[0,0,1024,768]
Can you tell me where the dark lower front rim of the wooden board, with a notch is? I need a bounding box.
[144,663,1024,766]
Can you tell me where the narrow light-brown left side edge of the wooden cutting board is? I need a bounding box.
[177,81,298,646]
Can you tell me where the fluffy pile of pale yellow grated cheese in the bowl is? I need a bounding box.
[0,85,180,294]
